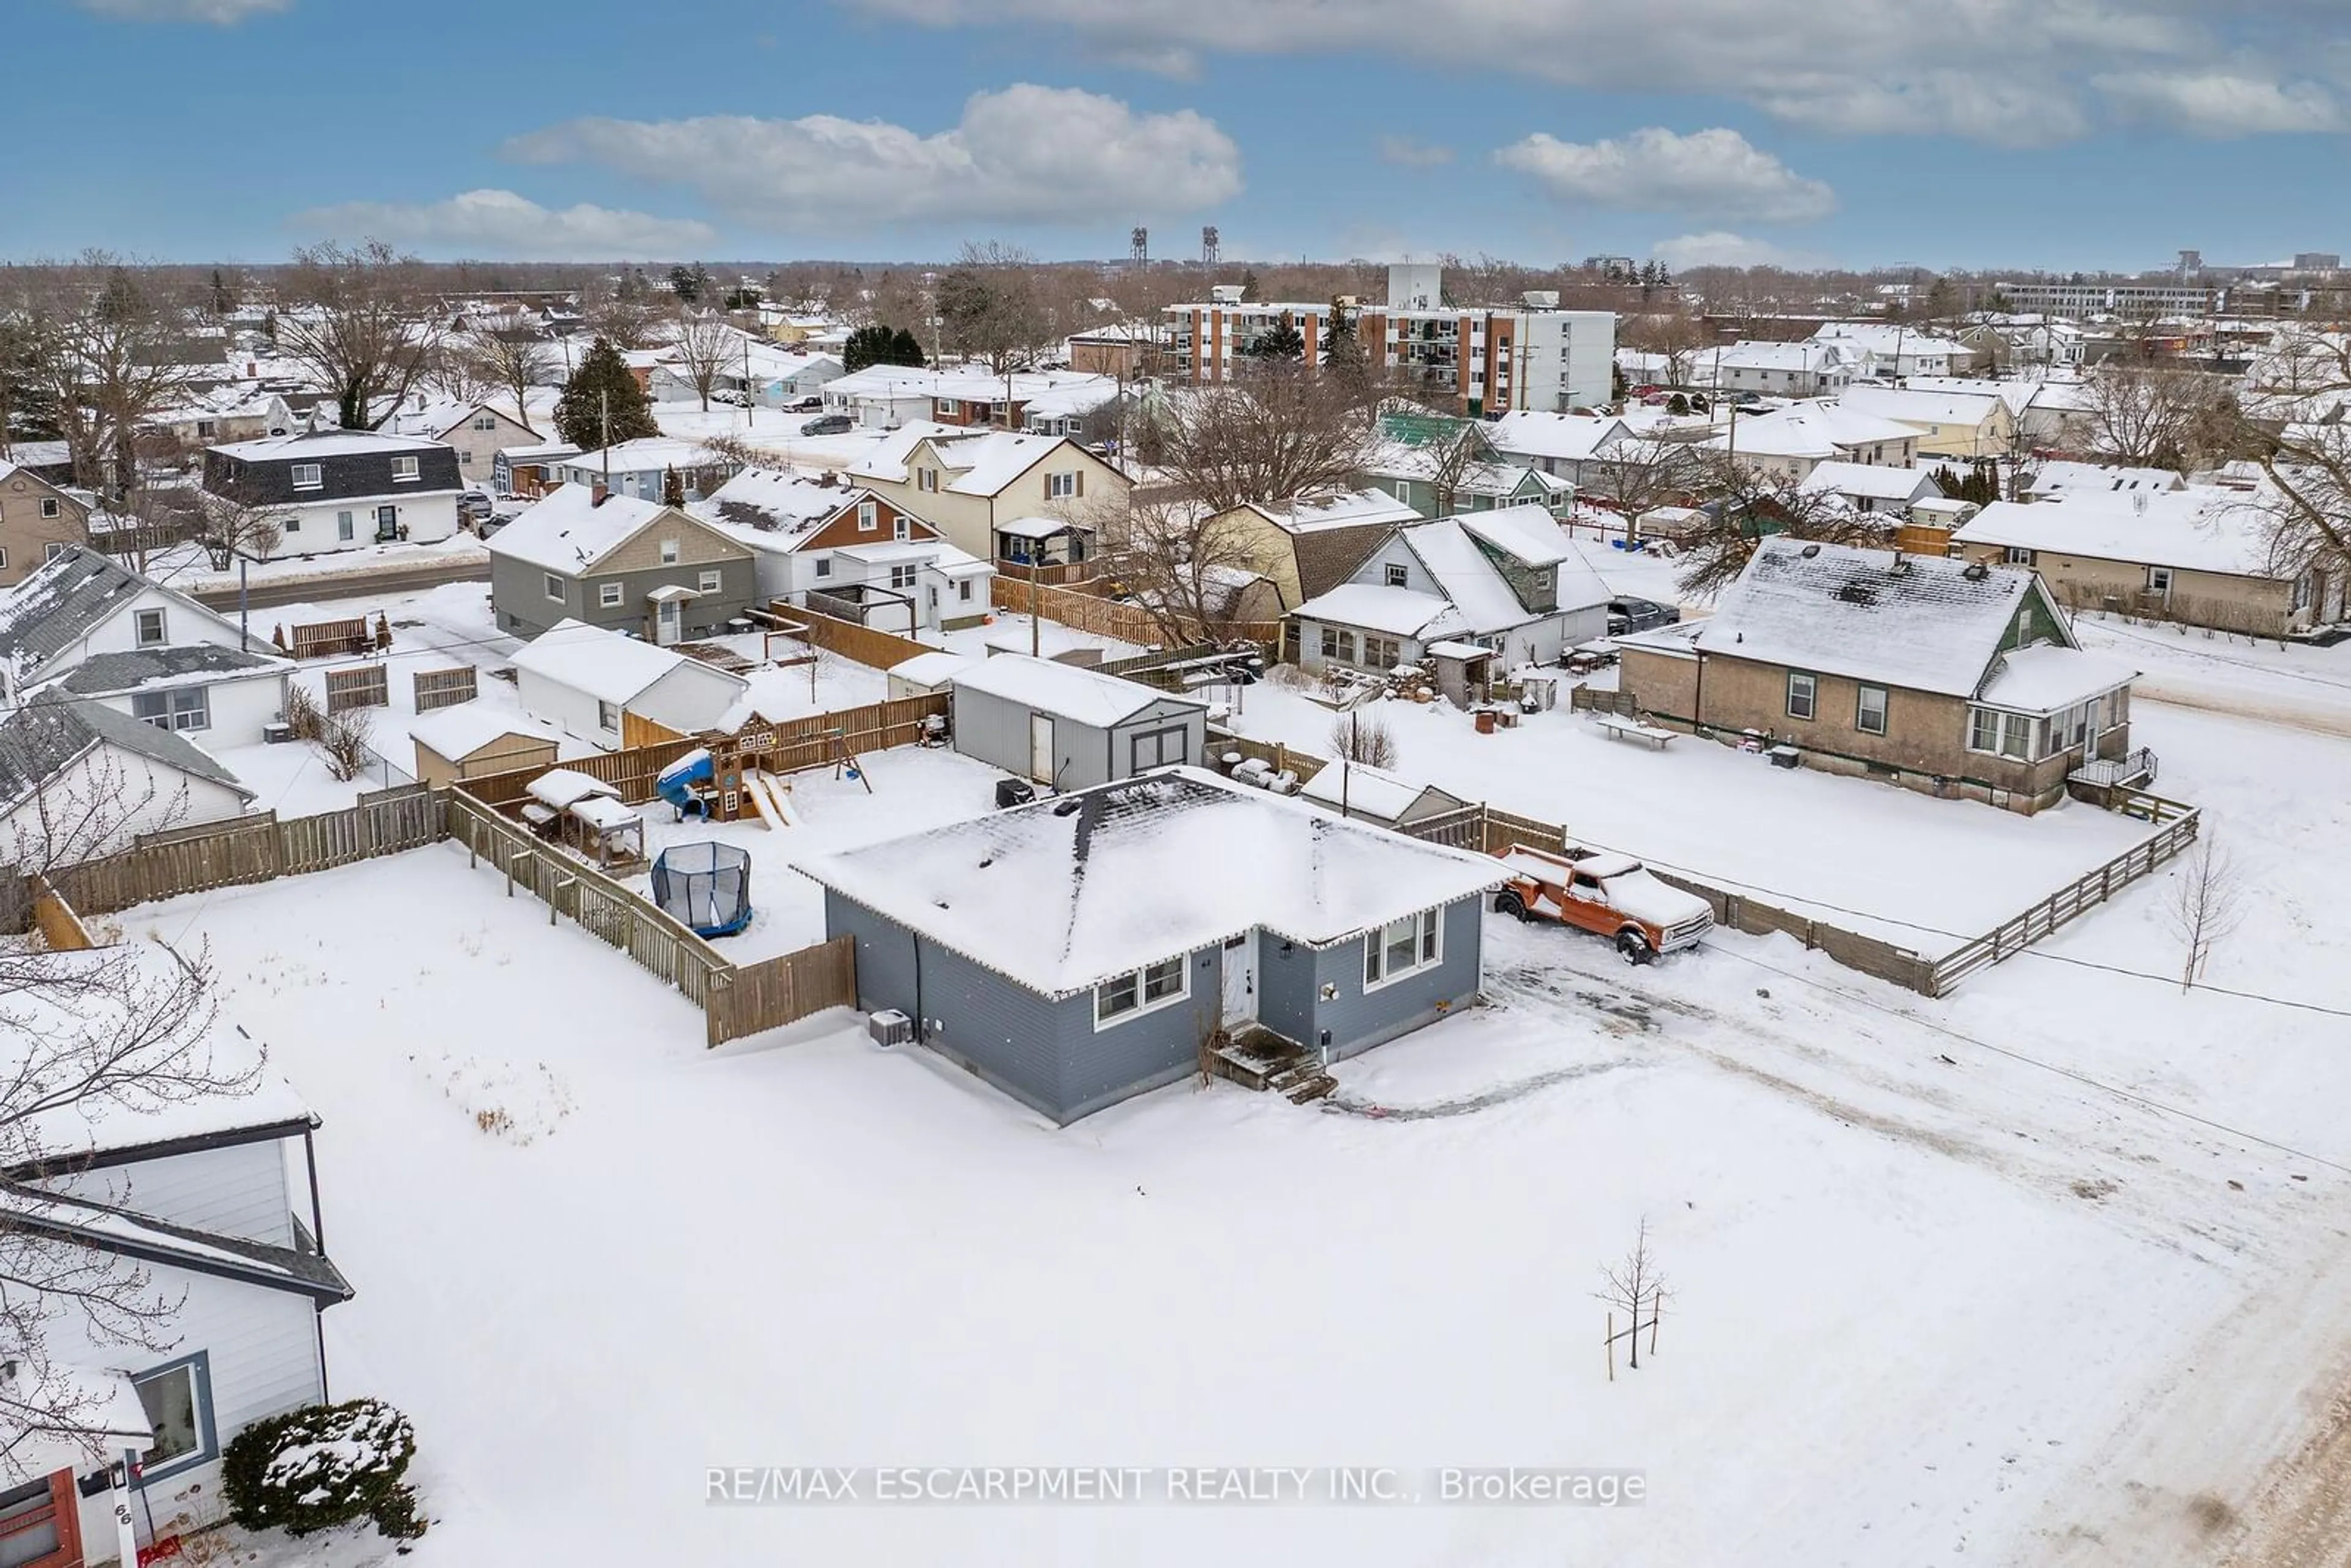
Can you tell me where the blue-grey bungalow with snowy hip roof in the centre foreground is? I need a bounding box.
[800,769,1500,1126]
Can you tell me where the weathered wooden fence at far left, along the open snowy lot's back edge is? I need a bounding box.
[50,785,449,917]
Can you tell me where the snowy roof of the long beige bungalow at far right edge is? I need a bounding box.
[1951,491,2273,579]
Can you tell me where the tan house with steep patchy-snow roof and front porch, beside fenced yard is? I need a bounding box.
[1618,538,2153,813]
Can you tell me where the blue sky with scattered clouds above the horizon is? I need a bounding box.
[0,0,2351,268]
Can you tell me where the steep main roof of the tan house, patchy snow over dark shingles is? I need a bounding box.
[1664,536,2036,696]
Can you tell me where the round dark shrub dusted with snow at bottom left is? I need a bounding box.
[221,1399,426,1540]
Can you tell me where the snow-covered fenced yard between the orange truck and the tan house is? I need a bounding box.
[1201,681,2147,955]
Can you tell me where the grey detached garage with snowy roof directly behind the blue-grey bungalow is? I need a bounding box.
[954,653,1209,790]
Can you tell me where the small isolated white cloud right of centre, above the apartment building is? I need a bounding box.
[1493,127,1836,223]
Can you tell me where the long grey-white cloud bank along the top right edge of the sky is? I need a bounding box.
[842,0,2342,146]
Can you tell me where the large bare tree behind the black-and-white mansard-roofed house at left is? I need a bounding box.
[277,240,440,430]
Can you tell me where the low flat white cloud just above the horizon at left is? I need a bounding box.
[287,190,717,261]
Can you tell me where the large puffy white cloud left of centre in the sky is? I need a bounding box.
[506,82,1242,233]
